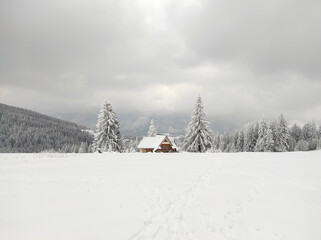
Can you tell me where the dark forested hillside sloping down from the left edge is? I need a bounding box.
[0,103,93,153]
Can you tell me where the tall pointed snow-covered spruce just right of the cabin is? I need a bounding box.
[183,97,213,152]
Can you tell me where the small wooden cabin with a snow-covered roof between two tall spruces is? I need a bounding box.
[138,135,178,153]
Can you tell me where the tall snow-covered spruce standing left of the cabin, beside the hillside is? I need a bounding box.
[93,101,123,152]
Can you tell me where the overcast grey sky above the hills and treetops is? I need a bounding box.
[0,0,321,127]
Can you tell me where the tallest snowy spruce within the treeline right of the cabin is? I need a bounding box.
[274,114,290,152]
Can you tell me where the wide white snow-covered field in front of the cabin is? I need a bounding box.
[0,151,321,240]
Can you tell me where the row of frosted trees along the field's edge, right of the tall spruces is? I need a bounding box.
[211,115,321,152]
